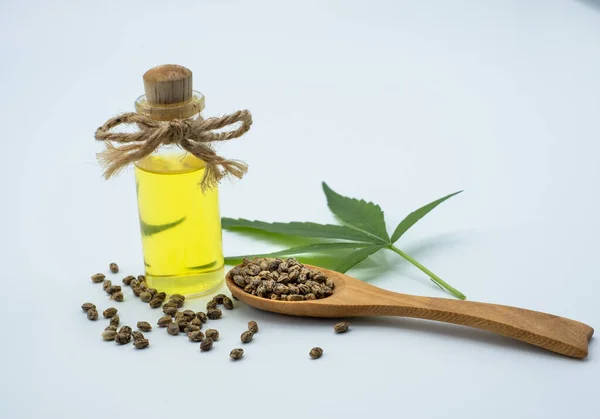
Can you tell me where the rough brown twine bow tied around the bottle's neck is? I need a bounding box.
[95,110,252,190]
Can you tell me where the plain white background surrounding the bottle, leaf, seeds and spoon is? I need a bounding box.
[0,0,600,419]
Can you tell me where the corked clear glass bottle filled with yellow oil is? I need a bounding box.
[135,65,224,296]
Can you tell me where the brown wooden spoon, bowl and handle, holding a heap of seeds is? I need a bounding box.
[226,265,594,358]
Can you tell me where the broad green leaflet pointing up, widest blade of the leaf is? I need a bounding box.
[323,182,390,244]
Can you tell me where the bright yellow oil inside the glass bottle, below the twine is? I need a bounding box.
[135,153,224,295]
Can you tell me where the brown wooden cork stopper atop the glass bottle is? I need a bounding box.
[143,64,193,105]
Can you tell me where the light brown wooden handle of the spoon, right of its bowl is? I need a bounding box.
[372,293,594,358]
